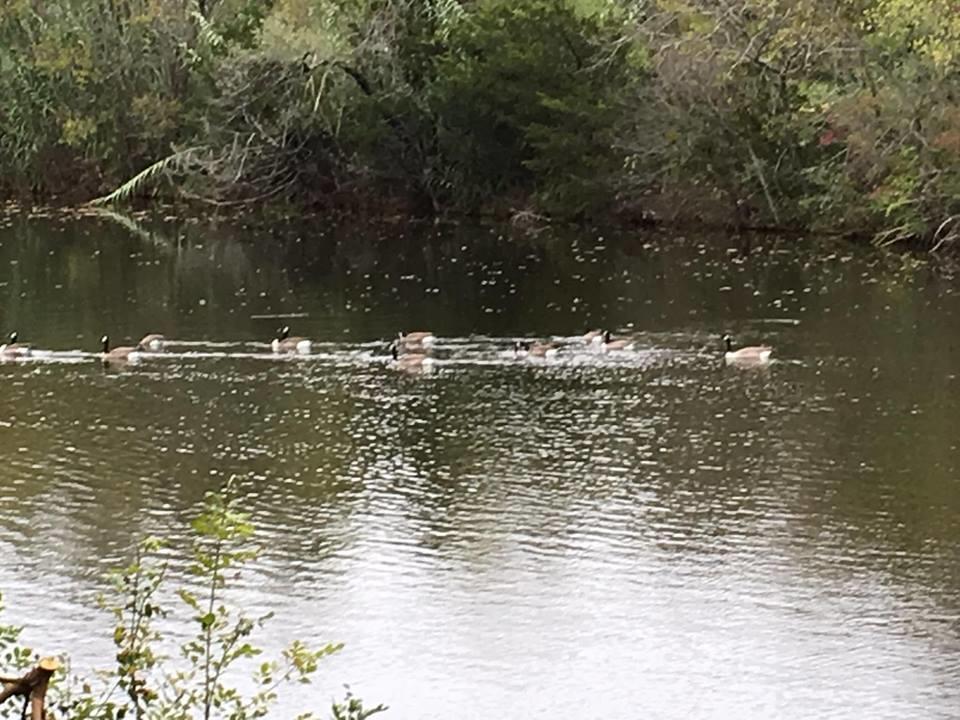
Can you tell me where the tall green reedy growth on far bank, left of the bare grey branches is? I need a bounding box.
[0,0,203,191]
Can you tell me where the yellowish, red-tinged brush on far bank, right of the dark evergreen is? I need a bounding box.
[631,0,960,242]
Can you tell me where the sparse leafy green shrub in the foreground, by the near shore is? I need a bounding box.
[0,480,376,720]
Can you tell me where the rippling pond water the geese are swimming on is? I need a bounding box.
[0,210,960,720]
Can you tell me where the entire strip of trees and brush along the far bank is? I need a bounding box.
[0,0,960,249]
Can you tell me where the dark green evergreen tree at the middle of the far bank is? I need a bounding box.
[431,0,625,215]
